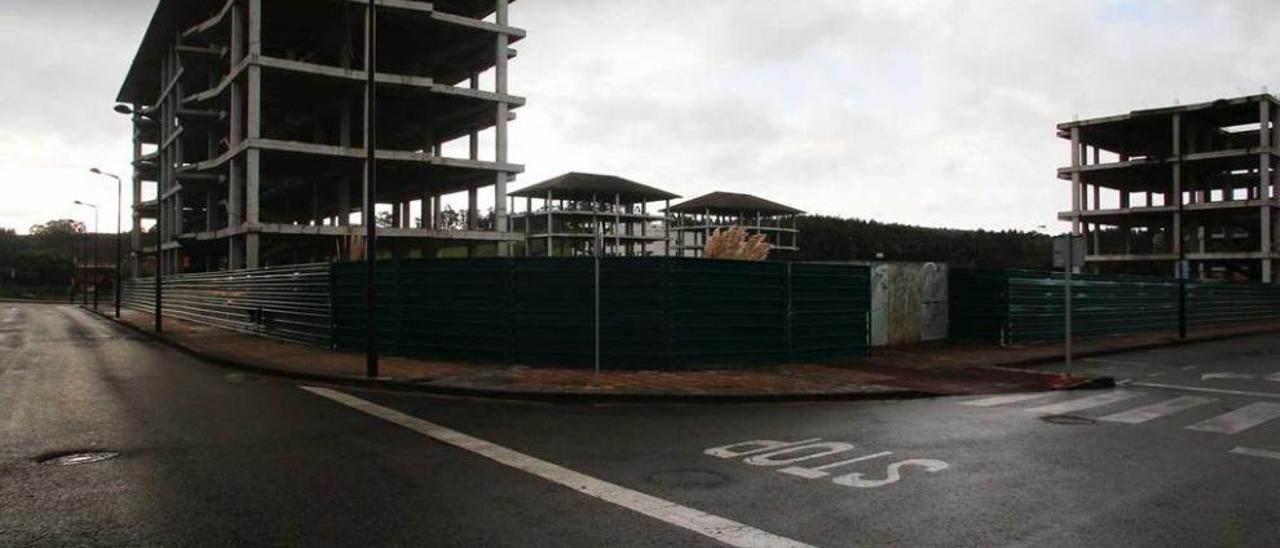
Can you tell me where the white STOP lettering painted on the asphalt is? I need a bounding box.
[703,438,951,489]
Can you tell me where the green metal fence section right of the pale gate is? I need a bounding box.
[950,269,1280,344]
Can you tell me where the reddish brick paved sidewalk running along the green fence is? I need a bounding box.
[94,310,1280,398]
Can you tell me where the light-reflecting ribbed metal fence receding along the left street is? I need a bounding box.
[122,262,333,347]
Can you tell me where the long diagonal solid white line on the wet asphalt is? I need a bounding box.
[301,387,809,548]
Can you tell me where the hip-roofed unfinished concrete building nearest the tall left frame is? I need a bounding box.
[511,173,680,257]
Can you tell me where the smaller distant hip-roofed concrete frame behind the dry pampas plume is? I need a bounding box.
[667,192,804,257]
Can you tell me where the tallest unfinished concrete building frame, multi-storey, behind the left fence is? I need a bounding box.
[116,0,525,273]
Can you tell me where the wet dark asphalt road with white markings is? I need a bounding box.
[0,303,1280,547]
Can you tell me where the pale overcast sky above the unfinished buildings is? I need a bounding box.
[0,0,1280,230]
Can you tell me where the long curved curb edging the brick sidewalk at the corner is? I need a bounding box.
[81,307,947,403]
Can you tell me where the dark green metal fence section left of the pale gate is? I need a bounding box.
[332,257,869,369]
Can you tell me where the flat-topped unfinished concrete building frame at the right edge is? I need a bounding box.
[1057,95,1280,283]
